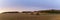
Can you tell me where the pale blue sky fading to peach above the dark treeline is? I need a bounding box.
[0,0,60,12]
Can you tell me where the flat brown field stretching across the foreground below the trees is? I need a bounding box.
[0,13,60,20]
